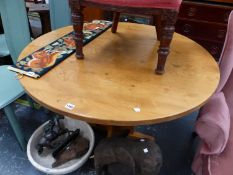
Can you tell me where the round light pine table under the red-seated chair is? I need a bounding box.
[19,23,220,138]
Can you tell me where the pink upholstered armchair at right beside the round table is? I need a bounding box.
[192,11,233,175]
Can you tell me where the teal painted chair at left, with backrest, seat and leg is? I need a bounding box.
[0,0,31,151]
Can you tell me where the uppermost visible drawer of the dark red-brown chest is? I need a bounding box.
[179,1,233,23]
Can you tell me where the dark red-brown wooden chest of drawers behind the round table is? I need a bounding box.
[176,0,233,60]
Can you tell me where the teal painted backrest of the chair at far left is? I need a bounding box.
[0,0,31,63]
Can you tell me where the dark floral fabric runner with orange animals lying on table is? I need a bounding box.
[8,20,112,78]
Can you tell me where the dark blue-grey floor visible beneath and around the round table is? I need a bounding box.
[0,96,197,175]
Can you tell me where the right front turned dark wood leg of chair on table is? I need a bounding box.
[155,10,178,74]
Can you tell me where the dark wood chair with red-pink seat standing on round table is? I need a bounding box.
[69,0,182,74]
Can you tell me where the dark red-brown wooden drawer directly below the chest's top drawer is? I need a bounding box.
[176,19,227,43]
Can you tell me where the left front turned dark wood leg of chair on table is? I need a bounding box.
[69,0,84,59]
